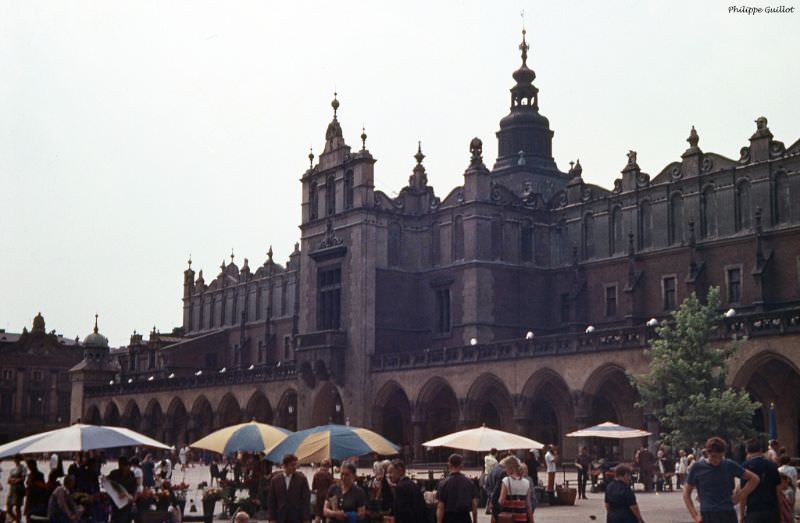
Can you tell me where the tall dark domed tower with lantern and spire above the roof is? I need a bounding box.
[492,29,568,200]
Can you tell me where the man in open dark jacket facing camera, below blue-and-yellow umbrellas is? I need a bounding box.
[267,454,311,523]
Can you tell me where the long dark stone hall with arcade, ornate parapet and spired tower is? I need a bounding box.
[75,32,800,461]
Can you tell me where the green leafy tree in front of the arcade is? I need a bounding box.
[631,287,758,448]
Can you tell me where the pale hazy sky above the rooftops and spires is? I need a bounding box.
[0,0,800,346]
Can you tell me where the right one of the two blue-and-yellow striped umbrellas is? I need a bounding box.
[267,424,399,463]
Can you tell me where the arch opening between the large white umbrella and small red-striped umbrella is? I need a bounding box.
[520,368,574,447]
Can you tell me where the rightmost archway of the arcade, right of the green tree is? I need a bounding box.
[733,351,800,456]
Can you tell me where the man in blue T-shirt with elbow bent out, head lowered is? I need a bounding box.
[683,437,759,523]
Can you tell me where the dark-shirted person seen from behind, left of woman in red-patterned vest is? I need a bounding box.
[436,454,478,523]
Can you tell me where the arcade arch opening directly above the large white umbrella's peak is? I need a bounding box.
[465,372,514,430]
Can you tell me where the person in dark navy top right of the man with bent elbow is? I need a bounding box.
[739,438,780,523]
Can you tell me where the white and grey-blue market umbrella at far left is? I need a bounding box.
[0,423,170,459]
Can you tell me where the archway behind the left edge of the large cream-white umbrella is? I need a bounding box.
[414,378,461,462]
